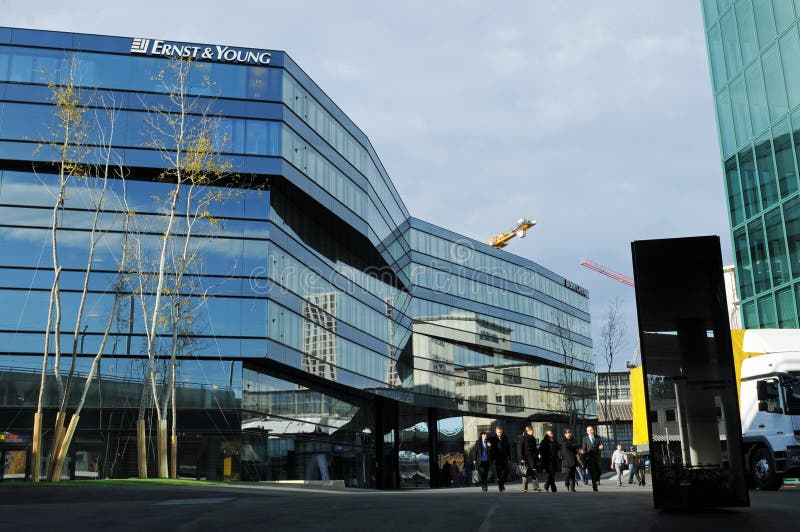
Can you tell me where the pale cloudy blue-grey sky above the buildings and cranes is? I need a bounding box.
[0,0,732,368]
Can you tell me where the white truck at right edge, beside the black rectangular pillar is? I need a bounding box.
[739,329,800,490]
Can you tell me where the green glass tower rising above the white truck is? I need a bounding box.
[702,0,800,328]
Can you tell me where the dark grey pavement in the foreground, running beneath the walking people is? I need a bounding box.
[0,481,800,532]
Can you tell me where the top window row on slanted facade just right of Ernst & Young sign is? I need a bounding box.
[283,73,408,225]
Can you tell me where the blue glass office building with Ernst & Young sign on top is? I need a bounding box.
[0,28,596,488]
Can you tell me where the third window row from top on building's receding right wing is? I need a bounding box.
[411,298,594,363]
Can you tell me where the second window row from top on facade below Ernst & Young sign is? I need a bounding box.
[0,102,282,156]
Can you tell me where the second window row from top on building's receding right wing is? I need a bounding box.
[411,264,591,338]
